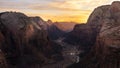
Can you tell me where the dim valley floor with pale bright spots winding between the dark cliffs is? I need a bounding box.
[42,38,80,68]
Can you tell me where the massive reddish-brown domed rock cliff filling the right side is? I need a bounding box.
[70,1,120,68]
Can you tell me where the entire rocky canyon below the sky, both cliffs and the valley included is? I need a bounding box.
[0,1,120,68]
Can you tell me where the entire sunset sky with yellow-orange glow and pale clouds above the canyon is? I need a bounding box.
[0,0,118,23]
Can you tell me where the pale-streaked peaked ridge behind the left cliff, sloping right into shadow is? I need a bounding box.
[30,17,65,40]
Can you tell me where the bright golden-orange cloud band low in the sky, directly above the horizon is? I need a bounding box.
[26,10,91,23]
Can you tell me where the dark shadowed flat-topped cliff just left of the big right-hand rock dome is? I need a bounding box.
[64,24,94,50]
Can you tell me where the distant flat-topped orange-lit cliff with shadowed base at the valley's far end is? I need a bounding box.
[47,20,75,40]
